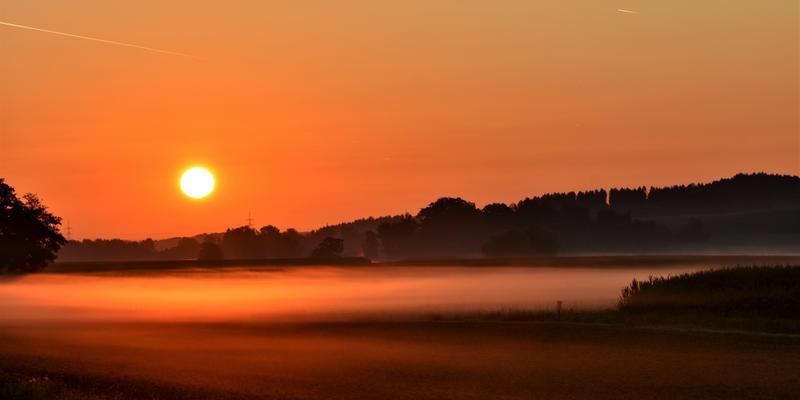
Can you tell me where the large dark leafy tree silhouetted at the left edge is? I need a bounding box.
[0,179,66,273]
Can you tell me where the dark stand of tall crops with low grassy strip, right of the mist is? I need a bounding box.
[429,265,800,335]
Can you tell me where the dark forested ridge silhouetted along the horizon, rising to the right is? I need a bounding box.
[58,173,800,261]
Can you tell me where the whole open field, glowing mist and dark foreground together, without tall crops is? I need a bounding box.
[0,256,800,400]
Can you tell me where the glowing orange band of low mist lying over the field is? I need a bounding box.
[0,266,699,322]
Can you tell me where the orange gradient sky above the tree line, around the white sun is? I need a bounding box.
[0,0,800,239]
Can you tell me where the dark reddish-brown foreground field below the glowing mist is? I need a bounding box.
[0,321,800,400]
